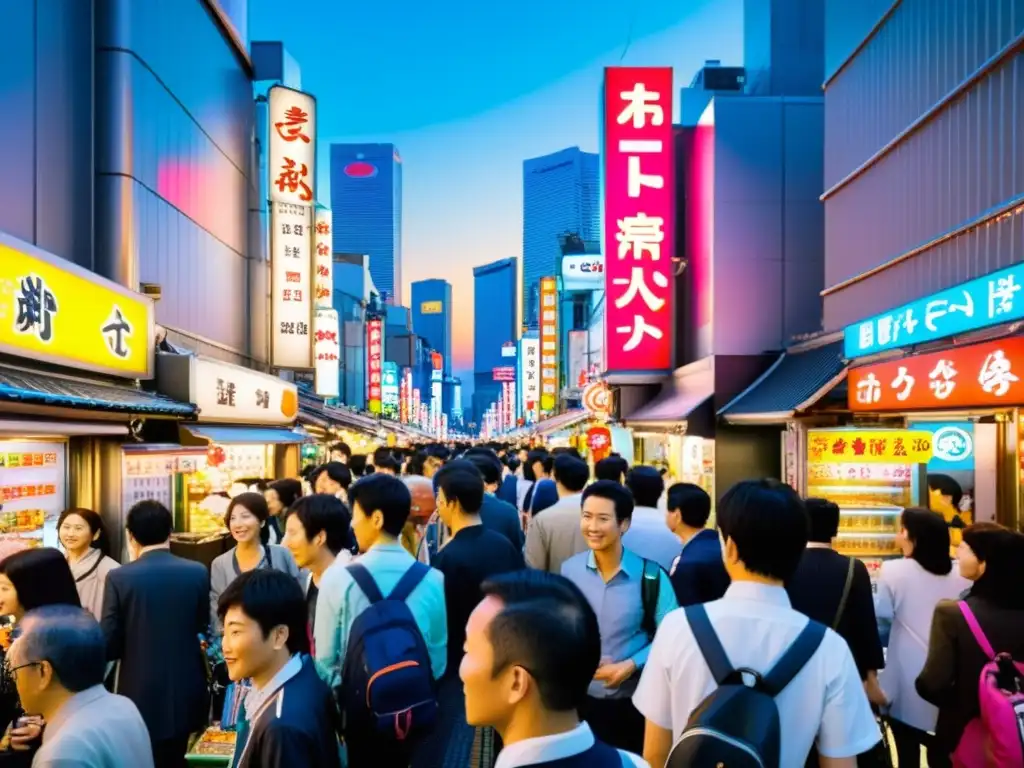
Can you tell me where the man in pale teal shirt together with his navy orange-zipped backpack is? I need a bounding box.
[314,473,447,768]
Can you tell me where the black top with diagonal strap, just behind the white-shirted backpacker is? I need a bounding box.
[785,547,885,680]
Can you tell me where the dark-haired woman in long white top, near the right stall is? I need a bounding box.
[874,508,970,766]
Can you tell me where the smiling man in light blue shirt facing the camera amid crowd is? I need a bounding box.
[562,480,679,752]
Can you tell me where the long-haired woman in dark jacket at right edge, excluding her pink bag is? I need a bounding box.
[916,522,1024,755]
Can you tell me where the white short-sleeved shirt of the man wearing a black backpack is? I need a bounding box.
[633,582,881,768]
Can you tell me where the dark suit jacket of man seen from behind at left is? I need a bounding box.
[102,550,210,741]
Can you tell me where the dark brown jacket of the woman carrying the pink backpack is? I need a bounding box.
[915,596,1024,752]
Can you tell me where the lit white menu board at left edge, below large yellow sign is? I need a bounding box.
[0,441,68,547]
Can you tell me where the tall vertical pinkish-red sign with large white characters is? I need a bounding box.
[604,67,675,374]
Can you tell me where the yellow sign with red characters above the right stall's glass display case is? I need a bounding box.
[807,429,932,464]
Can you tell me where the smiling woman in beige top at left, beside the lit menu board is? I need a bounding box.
[57,507,118,622]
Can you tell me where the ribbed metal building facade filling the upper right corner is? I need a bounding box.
[823,0,1024,330]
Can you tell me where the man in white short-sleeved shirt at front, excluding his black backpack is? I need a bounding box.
[633,480,881,768]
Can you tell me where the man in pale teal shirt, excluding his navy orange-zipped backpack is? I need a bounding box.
[314,473,447,686]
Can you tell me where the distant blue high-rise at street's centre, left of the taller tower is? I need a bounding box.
[473,259,520,428]
